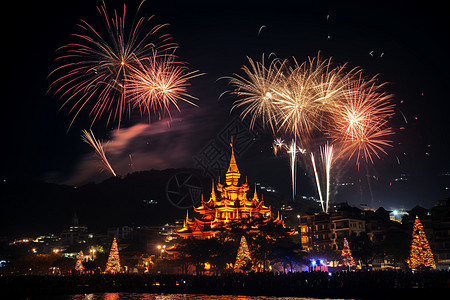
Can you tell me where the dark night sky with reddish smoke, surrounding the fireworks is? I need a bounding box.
[0,0,450,209]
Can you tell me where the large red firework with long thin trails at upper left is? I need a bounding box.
[49,5,176,128]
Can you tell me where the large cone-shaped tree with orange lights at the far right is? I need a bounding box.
[408,216,436,269]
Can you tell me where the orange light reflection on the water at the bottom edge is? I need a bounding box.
[59,293,348,300]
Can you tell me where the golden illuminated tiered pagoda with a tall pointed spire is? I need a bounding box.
[175,144,283,239]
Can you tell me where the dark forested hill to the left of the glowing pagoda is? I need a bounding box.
[0,169,211,236]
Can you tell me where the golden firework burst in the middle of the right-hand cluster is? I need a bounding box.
[276,56,353,143]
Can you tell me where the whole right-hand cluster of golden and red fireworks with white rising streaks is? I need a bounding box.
[230,55,393,207]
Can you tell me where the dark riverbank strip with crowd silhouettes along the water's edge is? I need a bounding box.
[0,271,450,299]
